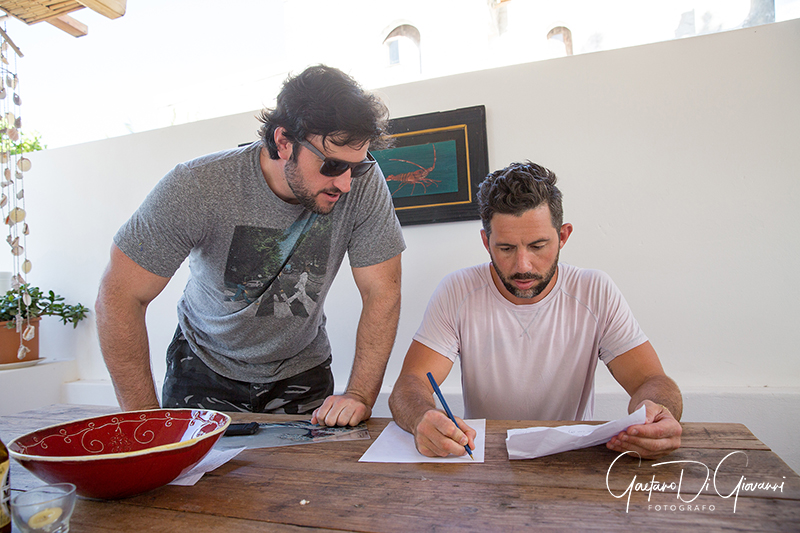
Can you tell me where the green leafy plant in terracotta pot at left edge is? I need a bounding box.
[0,283,89,364]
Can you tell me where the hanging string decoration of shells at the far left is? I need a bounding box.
[0,25,36,360]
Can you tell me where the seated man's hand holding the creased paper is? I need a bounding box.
[606,400,683,459]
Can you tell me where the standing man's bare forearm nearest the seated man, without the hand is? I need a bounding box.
[347,286,400,407]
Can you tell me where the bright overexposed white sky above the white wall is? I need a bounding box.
[0,0,800,148]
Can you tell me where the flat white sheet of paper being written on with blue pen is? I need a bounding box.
[358,418,486,463]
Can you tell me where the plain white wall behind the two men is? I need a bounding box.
[0,20,800,469]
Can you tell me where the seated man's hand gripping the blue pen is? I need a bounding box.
[414,409,478,457]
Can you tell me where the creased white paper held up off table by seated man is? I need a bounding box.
[506,406,646,459]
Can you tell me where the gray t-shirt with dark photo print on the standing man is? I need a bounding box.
[114,142,405,383]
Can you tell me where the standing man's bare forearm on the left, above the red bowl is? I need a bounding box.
[95,294,159,411]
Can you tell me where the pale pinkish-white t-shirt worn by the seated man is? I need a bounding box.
[414,263,647,420]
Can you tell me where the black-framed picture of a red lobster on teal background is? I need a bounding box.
[371,106,489,225]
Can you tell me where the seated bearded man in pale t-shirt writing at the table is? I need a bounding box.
[389,162,683,458]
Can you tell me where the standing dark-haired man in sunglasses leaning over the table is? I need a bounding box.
[96,65,405,426]
